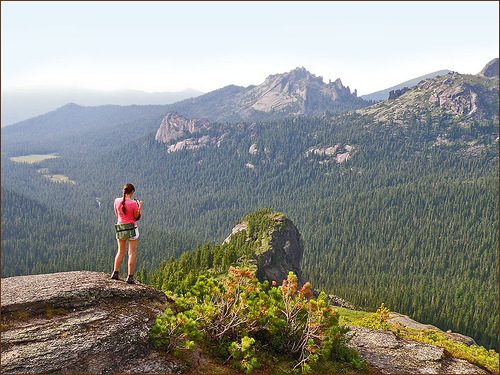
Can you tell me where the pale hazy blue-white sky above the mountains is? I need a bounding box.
[1,1,499,95]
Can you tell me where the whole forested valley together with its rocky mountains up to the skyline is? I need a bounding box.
[2,65,498,348]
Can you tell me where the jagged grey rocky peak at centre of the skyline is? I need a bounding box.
[166,67,370,122]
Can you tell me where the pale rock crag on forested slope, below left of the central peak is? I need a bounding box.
[155,112,210,143]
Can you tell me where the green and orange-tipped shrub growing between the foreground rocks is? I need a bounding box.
[151,267,362,373]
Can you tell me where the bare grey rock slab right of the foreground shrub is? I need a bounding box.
[348,326,488,374]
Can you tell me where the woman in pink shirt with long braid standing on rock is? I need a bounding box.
[111,184,142,284]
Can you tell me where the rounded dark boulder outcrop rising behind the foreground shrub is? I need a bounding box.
[224,212,304,285]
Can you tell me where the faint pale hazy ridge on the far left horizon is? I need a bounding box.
[2,89,202,127]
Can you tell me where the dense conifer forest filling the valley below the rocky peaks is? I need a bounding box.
[2,75,498,347]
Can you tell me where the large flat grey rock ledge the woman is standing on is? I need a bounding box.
[1,271,178,374]
